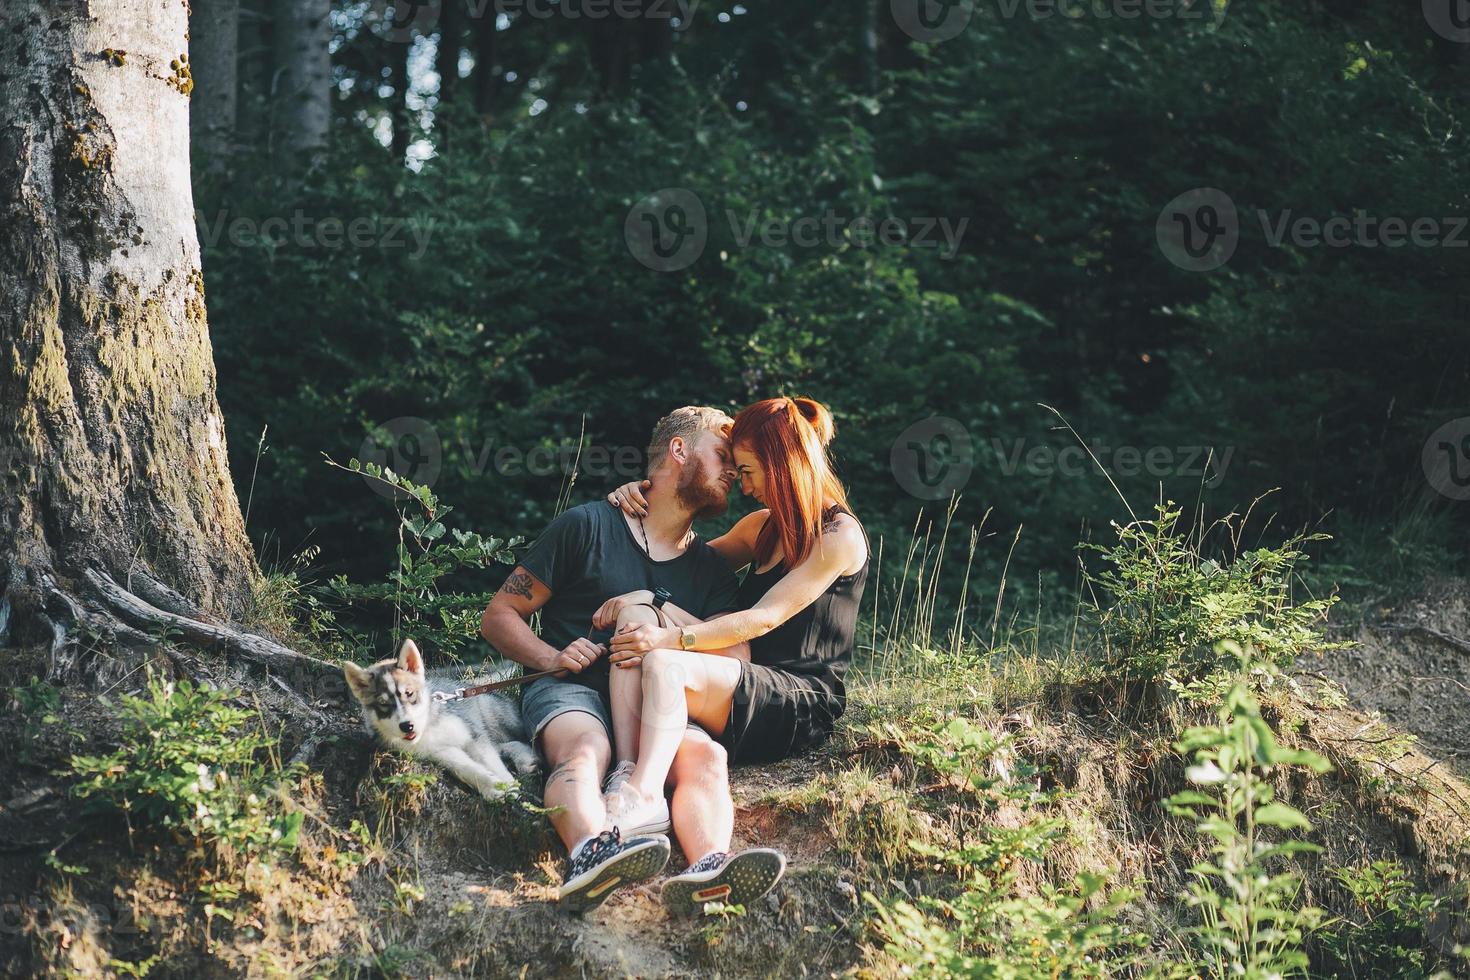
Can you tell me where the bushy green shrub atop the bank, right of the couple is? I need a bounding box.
[1083,501,1342,701]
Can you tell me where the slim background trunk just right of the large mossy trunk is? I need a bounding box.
[188,0,240,172]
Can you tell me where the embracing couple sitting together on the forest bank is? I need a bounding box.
[481,398,869,914]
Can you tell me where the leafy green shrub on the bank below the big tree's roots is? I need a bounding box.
[69,673,303,855]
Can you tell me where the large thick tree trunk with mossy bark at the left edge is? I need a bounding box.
[0,0,259,654]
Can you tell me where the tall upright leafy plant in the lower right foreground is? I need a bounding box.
[1164,642,1330,979]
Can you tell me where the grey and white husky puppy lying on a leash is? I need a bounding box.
[343,639,538,799]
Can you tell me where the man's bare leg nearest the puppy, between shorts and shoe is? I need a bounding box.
[541,711,612,852]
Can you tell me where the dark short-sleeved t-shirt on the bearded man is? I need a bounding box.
[520,501,739,692]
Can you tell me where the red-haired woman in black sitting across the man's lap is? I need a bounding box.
[594,398,869,910]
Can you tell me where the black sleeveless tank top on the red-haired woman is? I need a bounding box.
[738,505,872,696]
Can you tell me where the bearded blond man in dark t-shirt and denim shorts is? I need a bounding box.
[481,406,738,911]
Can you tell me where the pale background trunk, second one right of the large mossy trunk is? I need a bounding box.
[275,0,332,169]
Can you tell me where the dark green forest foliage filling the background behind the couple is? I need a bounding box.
[197,3,1470,643]
